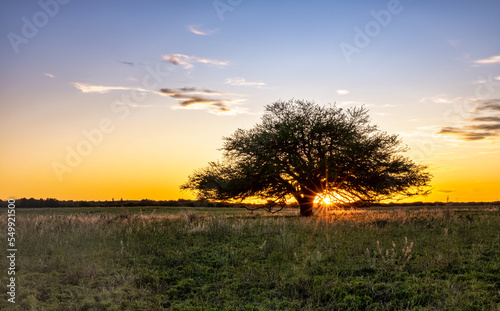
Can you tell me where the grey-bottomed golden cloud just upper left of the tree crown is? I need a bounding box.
[160,87,245,115]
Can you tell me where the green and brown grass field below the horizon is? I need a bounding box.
[0,206,500,310]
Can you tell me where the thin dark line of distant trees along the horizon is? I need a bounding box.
[0,198,500,208]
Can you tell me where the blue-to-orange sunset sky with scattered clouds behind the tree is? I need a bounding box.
[0,0,500,202]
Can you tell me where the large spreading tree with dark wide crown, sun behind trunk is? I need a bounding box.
[181,100,431,216]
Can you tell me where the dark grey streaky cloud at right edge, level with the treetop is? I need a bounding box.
[438,99,500,141]
